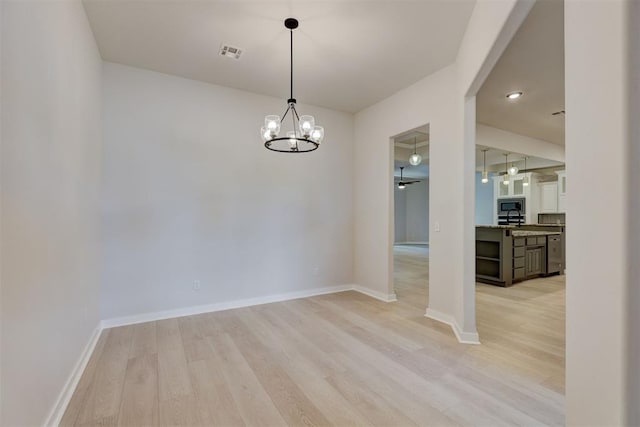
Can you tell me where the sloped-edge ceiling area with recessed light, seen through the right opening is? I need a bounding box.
[476,0,564,145]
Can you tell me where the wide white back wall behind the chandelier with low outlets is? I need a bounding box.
[101,63,360,319]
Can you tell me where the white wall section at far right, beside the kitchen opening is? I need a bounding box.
[565,0,640,425]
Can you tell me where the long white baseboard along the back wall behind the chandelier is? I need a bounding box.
[102,285,353,329]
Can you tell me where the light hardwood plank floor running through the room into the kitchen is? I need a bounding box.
[61,246,564,426]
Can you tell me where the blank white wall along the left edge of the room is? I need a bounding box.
[0,1,102,426]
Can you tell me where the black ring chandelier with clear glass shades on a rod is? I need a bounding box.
[260,18,324,153]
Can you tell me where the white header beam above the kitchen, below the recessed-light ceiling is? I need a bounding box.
[476,123,564,162]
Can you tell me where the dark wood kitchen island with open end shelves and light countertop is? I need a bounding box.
[476,225,564,286]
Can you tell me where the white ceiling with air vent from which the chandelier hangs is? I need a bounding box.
[84,0,475,112]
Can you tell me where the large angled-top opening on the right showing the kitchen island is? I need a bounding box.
[475,1,567,394]
